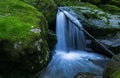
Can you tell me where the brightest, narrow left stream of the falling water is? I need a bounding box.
[56,11,67,50]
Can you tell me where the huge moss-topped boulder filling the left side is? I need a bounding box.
[0,0,49,78]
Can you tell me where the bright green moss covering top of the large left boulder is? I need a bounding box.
[0,0,42,45]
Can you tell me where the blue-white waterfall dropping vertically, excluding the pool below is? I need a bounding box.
[56,11,85,51]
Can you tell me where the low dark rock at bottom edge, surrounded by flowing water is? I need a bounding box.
[74,73,102,78]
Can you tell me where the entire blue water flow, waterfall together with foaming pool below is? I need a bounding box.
[39,8,108,78]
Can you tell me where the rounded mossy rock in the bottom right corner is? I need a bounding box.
[104,53,120,78]
